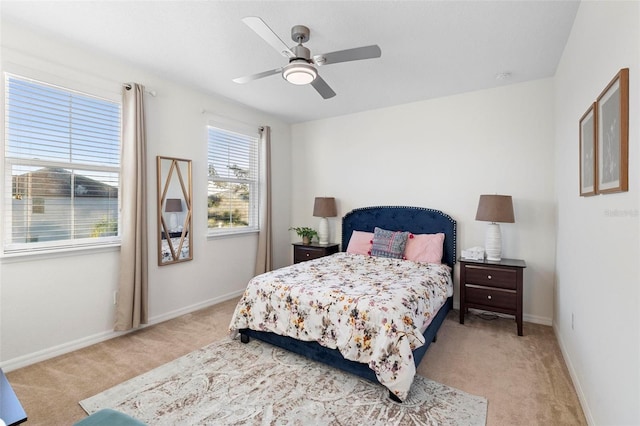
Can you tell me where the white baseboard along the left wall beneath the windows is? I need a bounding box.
[0,289,244,372]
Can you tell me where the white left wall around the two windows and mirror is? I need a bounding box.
[0,22,291,369]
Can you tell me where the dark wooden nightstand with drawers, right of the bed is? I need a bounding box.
[460,259,527,336]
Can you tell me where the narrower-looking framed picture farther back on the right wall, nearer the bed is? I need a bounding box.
[580,102,598,197]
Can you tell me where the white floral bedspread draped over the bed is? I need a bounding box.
[229,253,453,400]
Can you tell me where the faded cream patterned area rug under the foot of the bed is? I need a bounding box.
[80,339,487,425]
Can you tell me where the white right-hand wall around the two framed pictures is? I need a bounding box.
[554,1,640,425]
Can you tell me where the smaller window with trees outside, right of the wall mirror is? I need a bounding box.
[207,127,259,235]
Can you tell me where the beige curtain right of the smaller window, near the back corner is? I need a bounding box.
[255,126,273,275]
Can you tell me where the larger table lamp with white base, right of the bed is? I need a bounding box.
[476,195,515,261]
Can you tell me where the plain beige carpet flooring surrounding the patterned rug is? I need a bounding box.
[5,299,587,426]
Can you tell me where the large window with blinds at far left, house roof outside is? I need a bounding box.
[3,74,120,252]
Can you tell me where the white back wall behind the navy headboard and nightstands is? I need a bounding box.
[292,79,555,324]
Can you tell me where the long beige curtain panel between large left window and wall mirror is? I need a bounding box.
[114,83,148,331]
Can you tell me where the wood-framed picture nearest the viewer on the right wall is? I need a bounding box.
[596,68,629,194]
